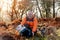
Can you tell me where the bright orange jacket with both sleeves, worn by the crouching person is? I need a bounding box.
[21,17,38,32]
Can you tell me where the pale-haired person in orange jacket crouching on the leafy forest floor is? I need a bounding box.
[17,11,38,37]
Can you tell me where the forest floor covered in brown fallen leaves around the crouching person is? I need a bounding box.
[0,19,60,40]
